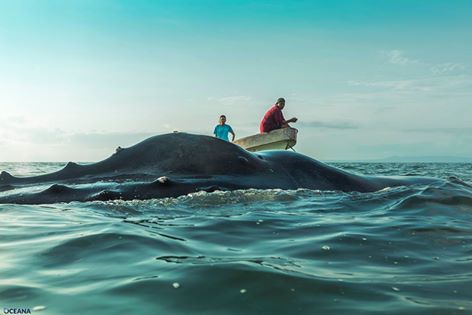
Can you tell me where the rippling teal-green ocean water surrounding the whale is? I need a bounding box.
[0,163,472,315]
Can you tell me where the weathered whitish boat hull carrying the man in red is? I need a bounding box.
[233,128,298,152]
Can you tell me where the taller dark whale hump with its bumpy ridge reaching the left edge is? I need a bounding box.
[0,133,269,185]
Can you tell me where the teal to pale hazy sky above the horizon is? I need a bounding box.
[0,0,472,162]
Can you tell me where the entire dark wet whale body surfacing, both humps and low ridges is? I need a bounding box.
[0,133,438,204]
